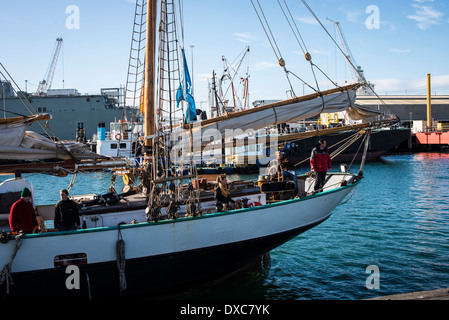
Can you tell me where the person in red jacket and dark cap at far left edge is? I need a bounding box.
[9,188,39,233]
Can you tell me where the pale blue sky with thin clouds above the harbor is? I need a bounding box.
[0,0,449,109]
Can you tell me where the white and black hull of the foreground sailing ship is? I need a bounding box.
[0,183,357,299]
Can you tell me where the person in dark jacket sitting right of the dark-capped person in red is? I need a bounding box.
[54,189,80,231]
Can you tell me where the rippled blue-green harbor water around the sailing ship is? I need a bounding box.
[0,153,449,300]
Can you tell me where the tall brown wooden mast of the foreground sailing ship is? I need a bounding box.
[143,0,157,149]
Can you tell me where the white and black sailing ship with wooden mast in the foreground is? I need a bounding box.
[0,0,400,299]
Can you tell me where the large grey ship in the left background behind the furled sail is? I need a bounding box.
[0,81,132,140]
